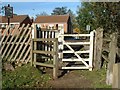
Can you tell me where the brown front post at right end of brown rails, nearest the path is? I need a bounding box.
[53,39,58,79]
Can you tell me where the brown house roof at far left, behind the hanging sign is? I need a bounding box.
[0,15,28,23]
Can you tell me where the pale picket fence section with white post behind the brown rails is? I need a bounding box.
[34,25,64,60]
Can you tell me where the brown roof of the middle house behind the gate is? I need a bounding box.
[34,15,69,23]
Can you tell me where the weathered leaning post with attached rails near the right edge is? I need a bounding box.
[102,33,117,85]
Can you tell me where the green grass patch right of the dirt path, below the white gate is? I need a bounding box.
[76,68,112,88]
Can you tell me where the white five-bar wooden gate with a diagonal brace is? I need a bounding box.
[60,31,94,71]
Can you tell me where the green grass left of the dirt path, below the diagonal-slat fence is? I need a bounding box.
[2,64,51,88]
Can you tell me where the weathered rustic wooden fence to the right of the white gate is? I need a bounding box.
[94,28,120,88]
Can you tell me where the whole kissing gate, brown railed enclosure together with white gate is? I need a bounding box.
[32,28,94,78]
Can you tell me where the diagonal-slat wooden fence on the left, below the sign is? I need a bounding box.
[0,24,32,63]
